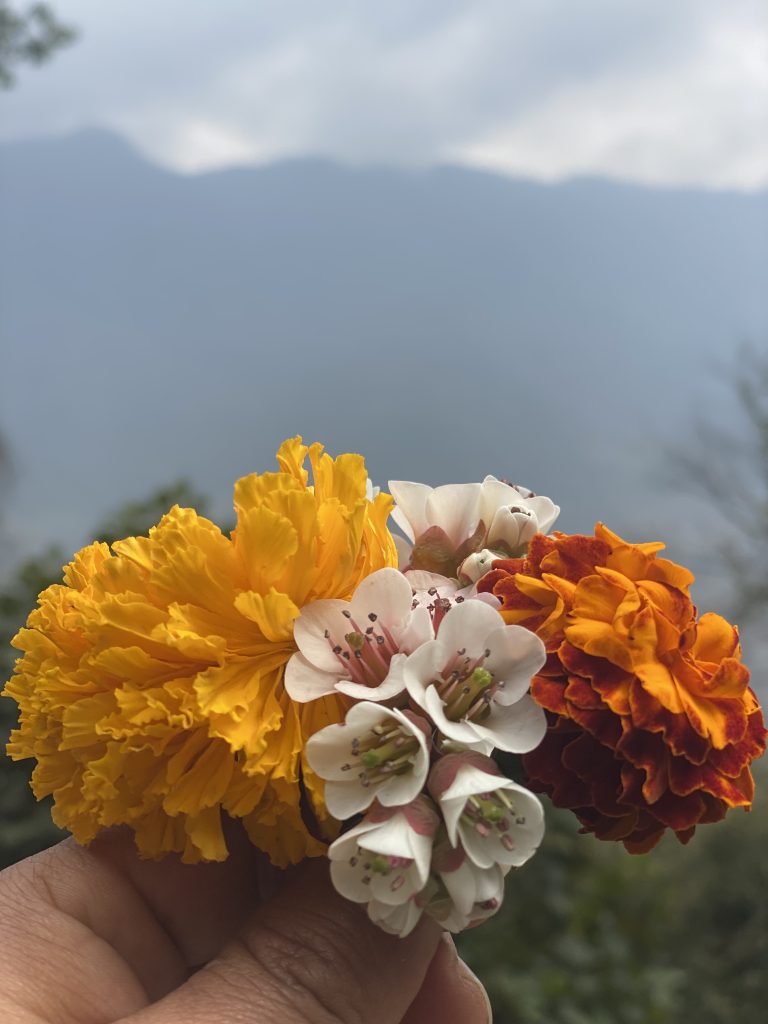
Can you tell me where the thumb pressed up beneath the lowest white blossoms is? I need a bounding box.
[124,861,440,1024]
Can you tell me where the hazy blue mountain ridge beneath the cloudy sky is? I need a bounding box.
[0,131,768,606]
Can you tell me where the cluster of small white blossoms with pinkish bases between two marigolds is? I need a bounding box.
[286,477,558,935]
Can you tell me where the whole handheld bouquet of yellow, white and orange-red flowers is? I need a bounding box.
[4,437,766,935]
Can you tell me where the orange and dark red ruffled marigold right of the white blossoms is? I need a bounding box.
[479,524,766,853]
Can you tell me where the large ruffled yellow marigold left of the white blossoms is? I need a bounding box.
[4,438,397,865]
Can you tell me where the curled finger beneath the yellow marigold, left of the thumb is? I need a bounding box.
[0,822,264,1024]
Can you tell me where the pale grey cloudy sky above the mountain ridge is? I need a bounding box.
[0,0,768,189]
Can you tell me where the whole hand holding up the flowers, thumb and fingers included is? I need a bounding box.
[0,829,490,1024]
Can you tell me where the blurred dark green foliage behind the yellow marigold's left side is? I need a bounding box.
[0,480,207,867]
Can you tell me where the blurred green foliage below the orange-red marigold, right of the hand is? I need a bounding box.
[459,768,768,1024]
